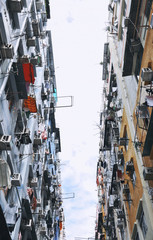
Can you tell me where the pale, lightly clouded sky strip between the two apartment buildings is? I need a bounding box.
[50,0,108,240]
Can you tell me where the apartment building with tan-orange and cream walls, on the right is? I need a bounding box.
[95,0,153,240]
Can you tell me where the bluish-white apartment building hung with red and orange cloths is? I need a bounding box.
[0,0,64,240]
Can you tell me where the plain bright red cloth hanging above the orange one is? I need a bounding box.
[22,63,35,84]
